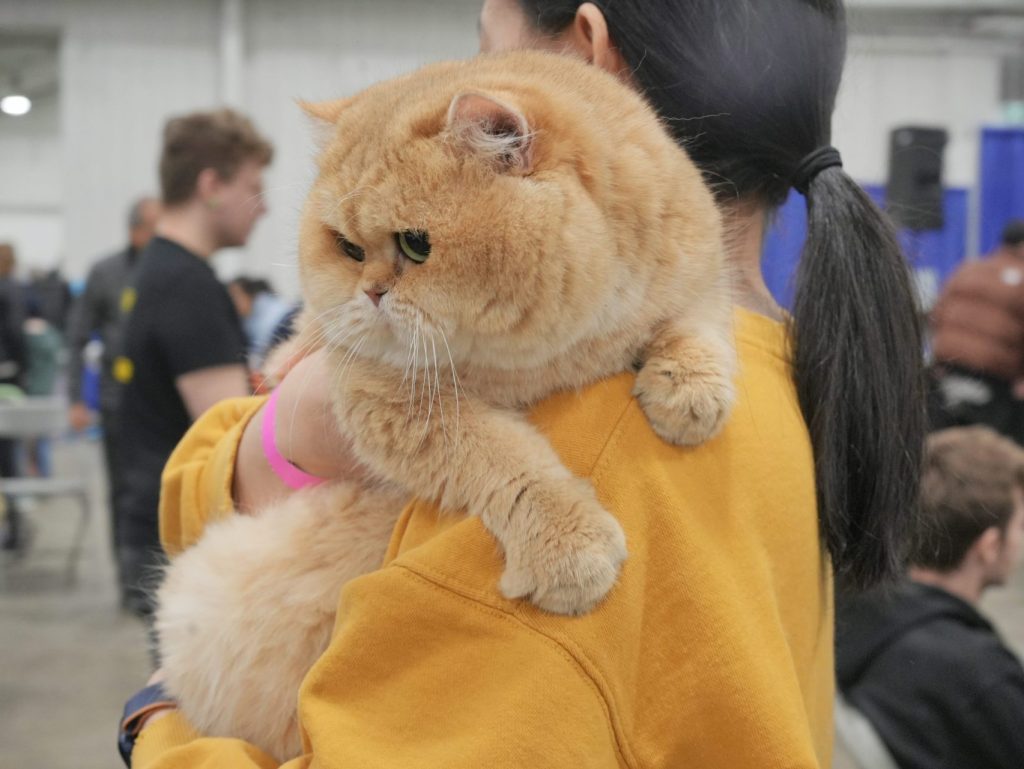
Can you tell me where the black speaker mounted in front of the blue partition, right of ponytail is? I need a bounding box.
[886,126,949,231]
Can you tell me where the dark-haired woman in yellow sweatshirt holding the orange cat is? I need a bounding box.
[125,0,923,769]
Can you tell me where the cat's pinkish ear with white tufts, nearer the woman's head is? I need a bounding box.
[447,91,534,175]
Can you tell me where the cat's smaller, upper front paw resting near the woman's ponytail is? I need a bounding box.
[633,354,736,445]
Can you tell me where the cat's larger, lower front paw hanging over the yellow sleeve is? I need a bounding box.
[501,479,626,614]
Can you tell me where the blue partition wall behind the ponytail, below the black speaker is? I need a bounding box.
[762,184,968,307]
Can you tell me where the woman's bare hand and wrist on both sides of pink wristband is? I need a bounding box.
[233,350,362,512]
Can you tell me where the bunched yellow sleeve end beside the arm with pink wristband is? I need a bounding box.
[160,397,266,556]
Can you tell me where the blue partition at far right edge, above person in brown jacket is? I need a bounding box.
[980,127,1024,254]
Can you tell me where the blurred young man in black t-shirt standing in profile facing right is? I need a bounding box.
[114,110,273,616]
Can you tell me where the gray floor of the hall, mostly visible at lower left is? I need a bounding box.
[0,440,1024,769]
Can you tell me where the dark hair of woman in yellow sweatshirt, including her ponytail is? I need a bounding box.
[519,0,925,587]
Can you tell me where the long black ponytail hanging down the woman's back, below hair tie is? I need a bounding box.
[791,168,925,588]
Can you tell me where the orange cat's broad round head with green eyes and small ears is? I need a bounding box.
[300,53,720,369]
